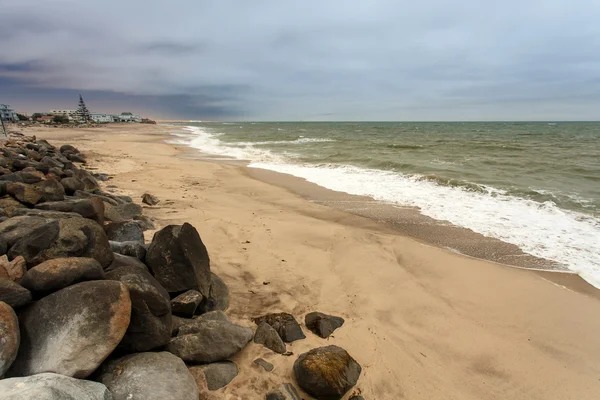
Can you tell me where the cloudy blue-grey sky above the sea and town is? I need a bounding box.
[0,0,600,121]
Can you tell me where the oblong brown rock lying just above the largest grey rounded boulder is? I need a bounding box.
[21,257,104,295]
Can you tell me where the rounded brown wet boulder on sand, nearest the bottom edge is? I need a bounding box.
[294,346,361,400]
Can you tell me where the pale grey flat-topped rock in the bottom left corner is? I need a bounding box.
[0,373,113,400]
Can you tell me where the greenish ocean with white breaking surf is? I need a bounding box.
[171,122,600,288]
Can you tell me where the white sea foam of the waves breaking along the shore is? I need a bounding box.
[171,127,600,288]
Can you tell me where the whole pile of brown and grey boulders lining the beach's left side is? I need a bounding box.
[0,134,361,400]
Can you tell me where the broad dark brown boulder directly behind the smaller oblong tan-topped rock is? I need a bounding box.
[8,218,114,268]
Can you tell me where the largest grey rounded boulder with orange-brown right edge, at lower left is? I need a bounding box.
[7,281,131,378]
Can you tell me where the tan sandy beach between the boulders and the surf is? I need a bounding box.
[17,125,600,400]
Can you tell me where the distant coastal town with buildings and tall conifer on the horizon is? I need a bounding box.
[0,96,156,125]
